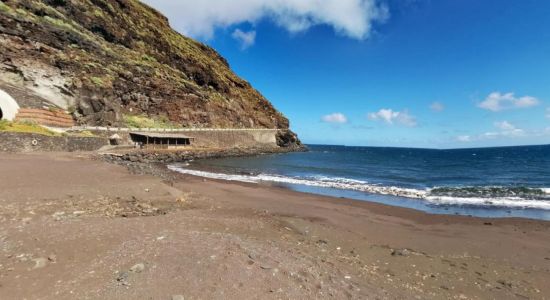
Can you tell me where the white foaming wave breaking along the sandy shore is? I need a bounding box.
[168,165,550,210]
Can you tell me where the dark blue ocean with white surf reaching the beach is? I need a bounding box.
[168,145,550,220]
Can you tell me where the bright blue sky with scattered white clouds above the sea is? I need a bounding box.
[145,0,550,148]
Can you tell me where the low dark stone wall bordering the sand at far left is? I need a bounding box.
[0,132,109,152]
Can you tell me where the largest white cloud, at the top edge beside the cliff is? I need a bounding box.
[143,0,389,39]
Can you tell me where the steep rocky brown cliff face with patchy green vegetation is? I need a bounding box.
[0,0,295,138]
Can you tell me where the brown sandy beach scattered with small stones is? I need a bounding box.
[0,153,550,299]
